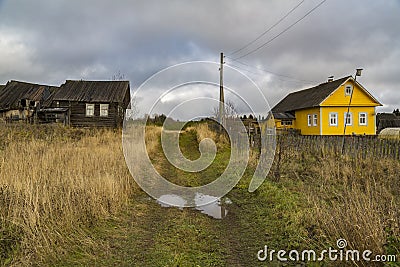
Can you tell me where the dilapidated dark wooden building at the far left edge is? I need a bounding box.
[0,81,57,122]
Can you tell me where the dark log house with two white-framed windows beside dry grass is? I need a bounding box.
[47,80,131,127]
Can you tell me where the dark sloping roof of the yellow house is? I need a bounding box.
[272,76,351,113]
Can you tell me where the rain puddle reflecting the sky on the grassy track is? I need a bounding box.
[157,193,232,219]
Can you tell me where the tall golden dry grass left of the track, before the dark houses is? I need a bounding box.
[0,125,135,266]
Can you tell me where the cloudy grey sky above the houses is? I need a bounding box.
[0,0,400,119]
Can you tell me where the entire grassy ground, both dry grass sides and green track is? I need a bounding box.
[0,124,400,266]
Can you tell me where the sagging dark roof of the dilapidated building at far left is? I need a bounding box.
[0,81,50,110]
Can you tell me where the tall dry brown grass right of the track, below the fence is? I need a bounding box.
[275,144,400,266]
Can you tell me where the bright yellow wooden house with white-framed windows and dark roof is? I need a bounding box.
[272,76,382,135]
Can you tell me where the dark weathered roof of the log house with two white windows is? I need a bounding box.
[52,80,130,103]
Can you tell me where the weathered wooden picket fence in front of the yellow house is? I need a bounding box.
[277,135,400,160]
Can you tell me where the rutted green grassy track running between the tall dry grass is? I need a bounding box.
[56,131,308,266]
